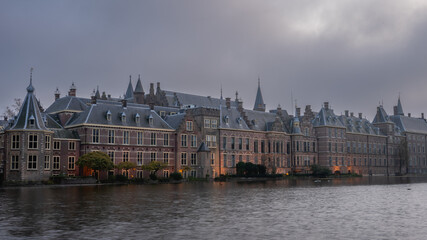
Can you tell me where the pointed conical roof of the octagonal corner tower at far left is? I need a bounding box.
[10,68,47,130]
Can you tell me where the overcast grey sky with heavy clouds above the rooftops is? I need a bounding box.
[0,0,427,120]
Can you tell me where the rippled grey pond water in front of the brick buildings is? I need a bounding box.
[0,178,427,239]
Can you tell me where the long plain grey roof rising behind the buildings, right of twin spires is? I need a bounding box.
[164,90,237,109]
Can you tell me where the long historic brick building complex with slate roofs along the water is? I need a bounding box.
[0,72,427,181]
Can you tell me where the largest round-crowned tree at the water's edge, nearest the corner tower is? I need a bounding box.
[76,152,114,181]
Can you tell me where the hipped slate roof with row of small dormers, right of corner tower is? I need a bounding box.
[67,103,172,129]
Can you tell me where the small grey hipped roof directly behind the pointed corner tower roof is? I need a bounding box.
[45,96,91,113]
